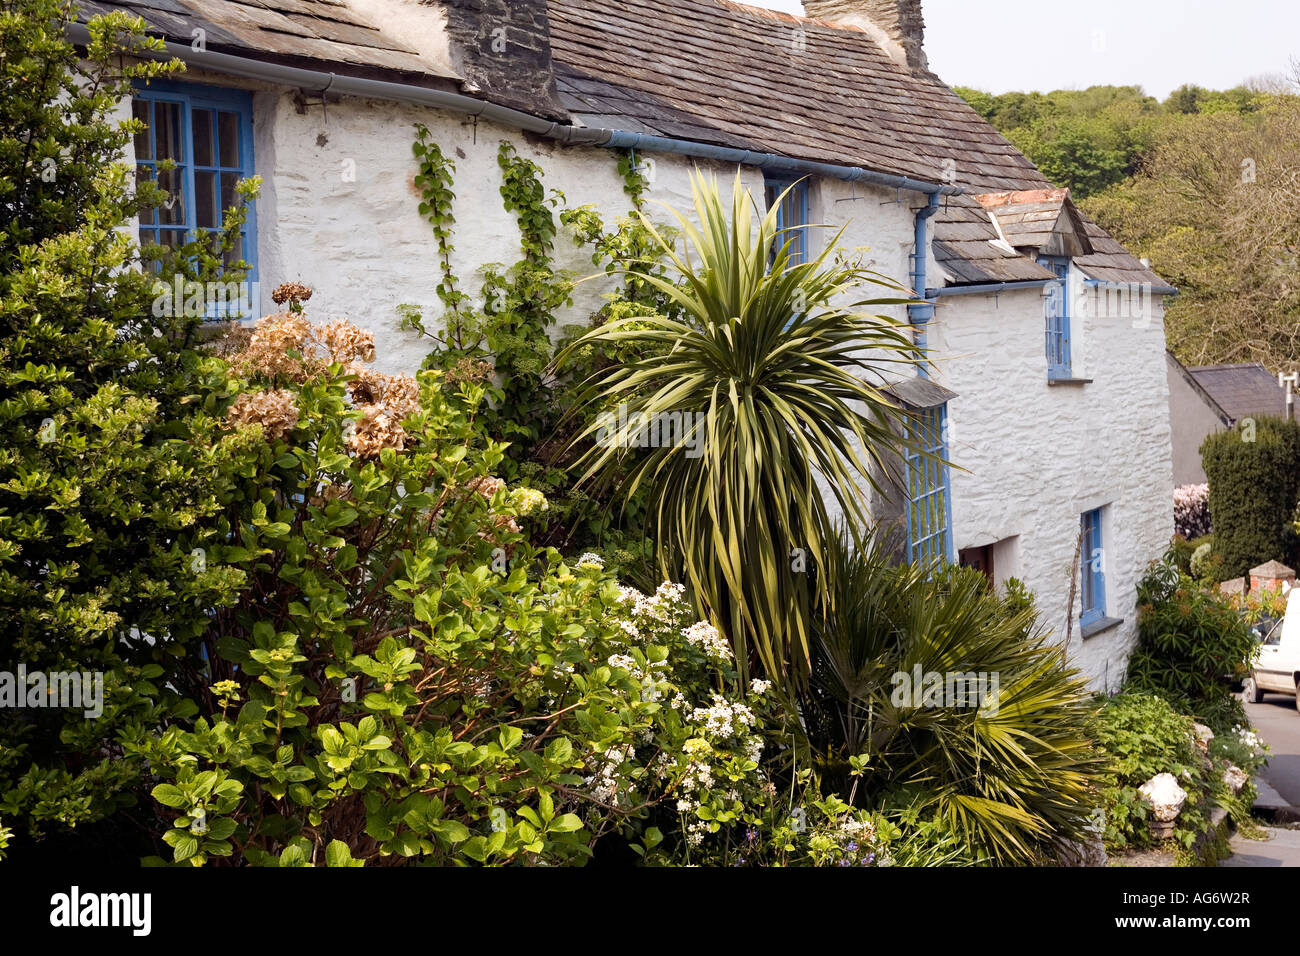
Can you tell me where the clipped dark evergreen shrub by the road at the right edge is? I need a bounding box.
[1201,416,1300,579]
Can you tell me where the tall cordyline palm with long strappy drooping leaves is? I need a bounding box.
[559,176,919,687]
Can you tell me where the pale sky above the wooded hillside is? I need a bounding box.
[745,0,1300,99]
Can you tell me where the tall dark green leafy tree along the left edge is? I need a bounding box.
[0,0,250,852]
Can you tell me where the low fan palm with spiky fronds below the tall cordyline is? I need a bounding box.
[800,538,1101,864]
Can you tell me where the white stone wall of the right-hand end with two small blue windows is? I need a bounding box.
[931,273,1173,689]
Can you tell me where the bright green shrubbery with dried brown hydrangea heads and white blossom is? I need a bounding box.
[130,303,832,865]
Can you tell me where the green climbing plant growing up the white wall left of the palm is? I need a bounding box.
[400,134,671,580]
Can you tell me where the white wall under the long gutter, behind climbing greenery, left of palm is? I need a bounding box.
[257,89,762,371]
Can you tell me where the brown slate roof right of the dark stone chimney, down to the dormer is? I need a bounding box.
[547,0,1166,286]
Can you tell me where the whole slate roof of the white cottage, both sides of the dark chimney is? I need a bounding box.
[82,0,1165,293]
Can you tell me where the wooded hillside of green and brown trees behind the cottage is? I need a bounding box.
[957,77,1300,372]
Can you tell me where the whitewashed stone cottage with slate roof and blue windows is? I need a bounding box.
[74,0,1173,687]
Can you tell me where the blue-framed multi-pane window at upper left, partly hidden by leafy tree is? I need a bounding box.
[131,81,257,282]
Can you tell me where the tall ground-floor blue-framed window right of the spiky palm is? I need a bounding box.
[905,405,953,564]
